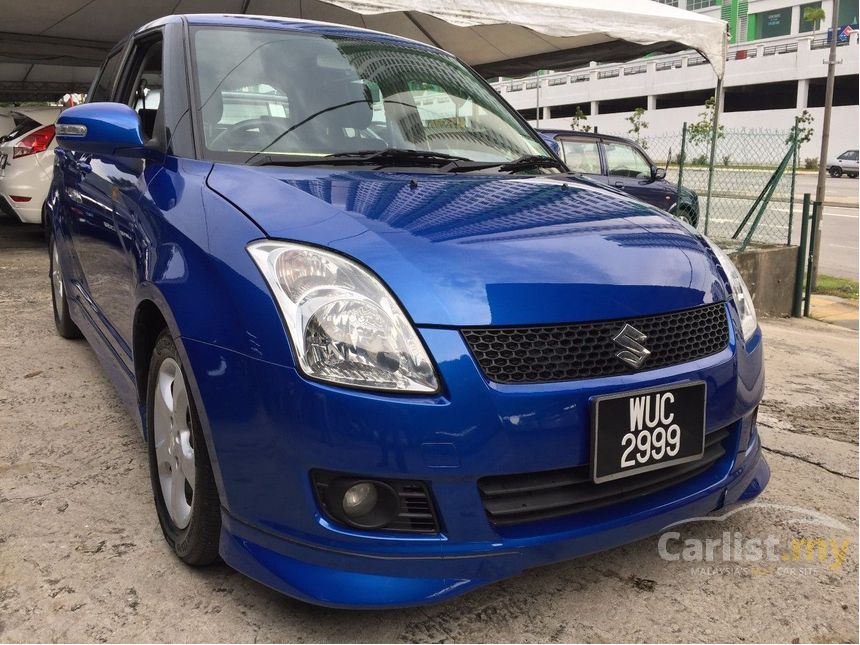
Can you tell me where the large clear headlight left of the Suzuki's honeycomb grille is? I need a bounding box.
[248,241,439,392]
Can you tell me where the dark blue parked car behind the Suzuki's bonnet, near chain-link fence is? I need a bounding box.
[540,130,699,228]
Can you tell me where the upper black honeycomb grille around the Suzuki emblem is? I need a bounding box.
[462,303,729,383]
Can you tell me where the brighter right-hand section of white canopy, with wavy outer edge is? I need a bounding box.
[318,0,727,77]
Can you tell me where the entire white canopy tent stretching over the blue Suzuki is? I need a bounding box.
[0,0,726,99]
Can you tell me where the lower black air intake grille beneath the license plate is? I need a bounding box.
[478,426,734,526]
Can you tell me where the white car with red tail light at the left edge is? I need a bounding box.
[0,108,60,225]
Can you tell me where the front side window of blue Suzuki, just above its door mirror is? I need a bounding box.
[117,37,164,138]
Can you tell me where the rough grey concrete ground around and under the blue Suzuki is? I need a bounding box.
[0,219,858,642]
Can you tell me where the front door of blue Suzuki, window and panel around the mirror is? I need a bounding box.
[67,31,163,370]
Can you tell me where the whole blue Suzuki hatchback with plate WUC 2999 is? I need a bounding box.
[46,15,769,607]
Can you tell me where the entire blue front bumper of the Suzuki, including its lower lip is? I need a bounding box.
[182,304,769,607]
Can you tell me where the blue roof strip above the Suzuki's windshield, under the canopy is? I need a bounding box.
[134,13,444,56]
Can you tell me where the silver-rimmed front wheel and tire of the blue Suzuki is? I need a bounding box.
[146,330,221,566]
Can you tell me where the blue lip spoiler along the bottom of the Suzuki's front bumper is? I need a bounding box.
[221,436,770,609]
